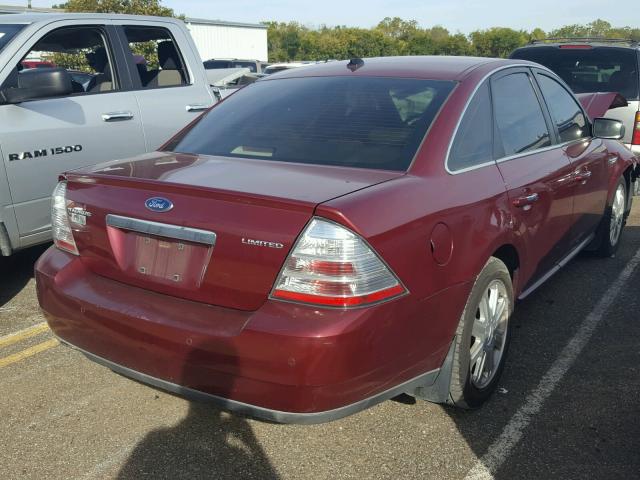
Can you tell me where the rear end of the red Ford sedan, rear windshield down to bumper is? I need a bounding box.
[37,65,457,423]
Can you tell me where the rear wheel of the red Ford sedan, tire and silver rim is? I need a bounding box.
[449,257,514,409]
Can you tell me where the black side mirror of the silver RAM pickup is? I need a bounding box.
[0,68,73,103]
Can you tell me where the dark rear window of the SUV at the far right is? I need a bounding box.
[512,47,640,100]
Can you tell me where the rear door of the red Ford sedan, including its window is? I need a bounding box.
[491,68,573,290]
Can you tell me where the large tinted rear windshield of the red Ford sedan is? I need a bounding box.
[169,77,454,170]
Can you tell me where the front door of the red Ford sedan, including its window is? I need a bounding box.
[534,69,618,246]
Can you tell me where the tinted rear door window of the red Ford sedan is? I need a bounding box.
[492,73,551,156]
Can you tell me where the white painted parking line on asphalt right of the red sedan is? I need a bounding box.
[465,250,640,480]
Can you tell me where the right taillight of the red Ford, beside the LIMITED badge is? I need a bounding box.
[271,218,406,307]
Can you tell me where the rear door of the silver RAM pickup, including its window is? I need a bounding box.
[112,20,215,151]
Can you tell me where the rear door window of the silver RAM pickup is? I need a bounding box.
[124,26,189,88]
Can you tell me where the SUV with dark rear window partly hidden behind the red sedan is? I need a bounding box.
[510,38,640,153]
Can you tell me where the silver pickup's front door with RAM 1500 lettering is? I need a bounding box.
[0,20,145,242]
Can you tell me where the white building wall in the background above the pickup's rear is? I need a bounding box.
[187,20,268,62]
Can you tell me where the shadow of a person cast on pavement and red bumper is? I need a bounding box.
[117,342,279,480]
